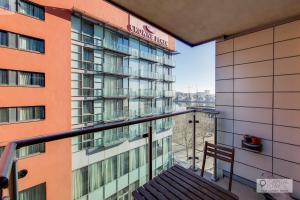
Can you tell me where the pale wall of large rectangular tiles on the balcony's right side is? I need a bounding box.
[216,20,300,198]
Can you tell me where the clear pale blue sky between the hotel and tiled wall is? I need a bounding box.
[174,40,215,93]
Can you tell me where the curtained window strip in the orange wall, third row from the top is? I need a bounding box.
[0,69,45,87]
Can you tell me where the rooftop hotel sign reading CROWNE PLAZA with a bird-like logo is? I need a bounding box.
[127,15,168,47]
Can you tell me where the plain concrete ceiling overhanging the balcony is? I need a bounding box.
[107,0,300,46]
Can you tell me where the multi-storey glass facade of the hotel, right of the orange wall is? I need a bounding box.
[71,14,175,200]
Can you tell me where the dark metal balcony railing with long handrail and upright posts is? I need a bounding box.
[0,109,218,200]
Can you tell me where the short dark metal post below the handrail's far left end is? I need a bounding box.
[8,159,19,200]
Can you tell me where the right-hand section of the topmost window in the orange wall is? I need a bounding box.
[18,0,45,20]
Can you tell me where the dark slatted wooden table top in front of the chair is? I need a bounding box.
[132,165,238,200]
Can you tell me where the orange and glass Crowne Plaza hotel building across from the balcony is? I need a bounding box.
[0,0,175,200]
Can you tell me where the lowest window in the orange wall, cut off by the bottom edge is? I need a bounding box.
[19,183,46,200]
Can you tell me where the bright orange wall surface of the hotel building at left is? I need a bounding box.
[0,0,175,200]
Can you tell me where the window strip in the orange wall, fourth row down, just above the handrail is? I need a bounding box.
[0,106,45,124]
